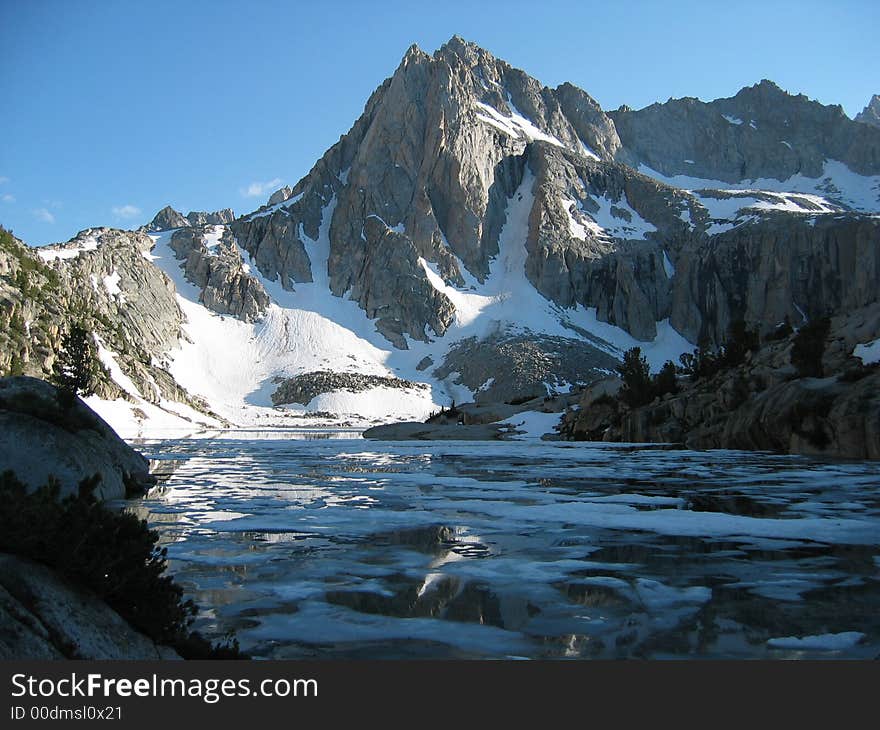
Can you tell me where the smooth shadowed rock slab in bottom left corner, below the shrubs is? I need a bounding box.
[0,554,180,661]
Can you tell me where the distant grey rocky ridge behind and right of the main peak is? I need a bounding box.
[609,80,880,182]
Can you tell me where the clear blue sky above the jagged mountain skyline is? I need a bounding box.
[0,0,880,245]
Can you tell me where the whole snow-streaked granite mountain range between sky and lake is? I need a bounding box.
[0,37,880,432]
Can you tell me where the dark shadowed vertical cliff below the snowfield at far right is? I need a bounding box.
[671,214,880,343]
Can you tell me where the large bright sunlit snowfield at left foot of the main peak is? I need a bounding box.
[152,199,445,426]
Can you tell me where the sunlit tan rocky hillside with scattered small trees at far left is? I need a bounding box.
[0,228,208,411]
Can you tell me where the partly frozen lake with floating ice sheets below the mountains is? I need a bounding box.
[134,433,880,659]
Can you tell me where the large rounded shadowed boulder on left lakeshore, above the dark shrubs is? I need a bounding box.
[0,377,154,499]
